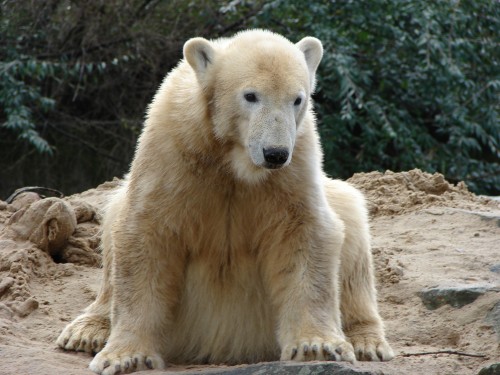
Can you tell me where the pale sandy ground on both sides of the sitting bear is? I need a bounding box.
[0,170,500,375]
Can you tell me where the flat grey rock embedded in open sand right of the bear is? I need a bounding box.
[417,284,494,310]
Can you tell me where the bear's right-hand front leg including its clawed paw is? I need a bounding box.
[263,214,355,362]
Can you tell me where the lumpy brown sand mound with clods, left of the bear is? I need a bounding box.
[0,182,117,323]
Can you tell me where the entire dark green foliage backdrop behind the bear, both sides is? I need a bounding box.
[0,0,500,194]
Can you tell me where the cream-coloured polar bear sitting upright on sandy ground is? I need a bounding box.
[57,30,394,374]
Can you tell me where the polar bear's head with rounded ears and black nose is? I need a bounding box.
[184,30,323,182]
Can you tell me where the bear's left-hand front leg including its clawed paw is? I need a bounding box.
[89,223,185,375]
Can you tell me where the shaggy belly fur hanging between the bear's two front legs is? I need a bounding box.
[169,258,278,363]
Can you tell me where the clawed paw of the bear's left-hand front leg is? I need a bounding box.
[89,345,165,375]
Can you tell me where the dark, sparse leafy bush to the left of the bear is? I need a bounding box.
[0,0,260,198]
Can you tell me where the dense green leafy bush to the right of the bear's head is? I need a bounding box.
[250,0,500,194]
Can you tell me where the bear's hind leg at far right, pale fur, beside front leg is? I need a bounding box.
[326,180,394,361]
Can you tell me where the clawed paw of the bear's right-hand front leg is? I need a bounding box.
[280,337,356,363]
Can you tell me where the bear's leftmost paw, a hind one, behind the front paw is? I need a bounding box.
[56,314,109,353]
